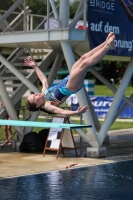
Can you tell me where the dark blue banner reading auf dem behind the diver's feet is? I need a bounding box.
[88,0,133,57]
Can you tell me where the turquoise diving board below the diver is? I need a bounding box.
[0,119,92,129]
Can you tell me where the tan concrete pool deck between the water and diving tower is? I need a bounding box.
[0,129,133,178]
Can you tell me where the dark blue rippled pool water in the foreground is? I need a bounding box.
[0,160,133,200]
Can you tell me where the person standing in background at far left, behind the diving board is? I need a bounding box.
[0,102,12,145]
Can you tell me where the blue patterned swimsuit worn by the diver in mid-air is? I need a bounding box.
[45,75,81,103]
